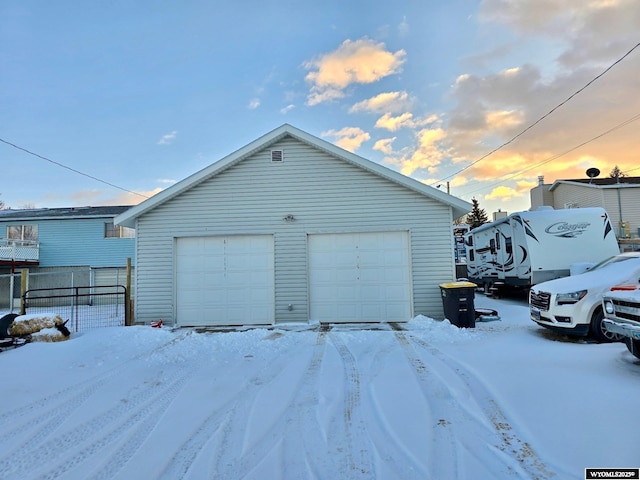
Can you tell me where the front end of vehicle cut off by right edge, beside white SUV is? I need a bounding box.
[602,284,640,358]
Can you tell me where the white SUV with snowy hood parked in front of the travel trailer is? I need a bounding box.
[529,252,640,342]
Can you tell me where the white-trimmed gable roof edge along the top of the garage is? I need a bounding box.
[115,124,472,227]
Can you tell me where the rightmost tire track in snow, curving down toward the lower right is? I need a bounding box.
[410,337,571,480]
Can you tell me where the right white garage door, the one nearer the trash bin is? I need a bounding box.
[308,232,411,323]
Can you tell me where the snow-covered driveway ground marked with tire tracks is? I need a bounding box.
[0,295,640,480]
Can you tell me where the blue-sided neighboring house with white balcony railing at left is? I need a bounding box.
[0,206,135,285]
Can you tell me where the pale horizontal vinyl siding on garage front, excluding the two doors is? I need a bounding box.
[136,137,455,323]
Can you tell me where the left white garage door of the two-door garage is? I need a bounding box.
[176,235,275,326]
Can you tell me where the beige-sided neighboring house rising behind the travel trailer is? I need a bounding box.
[531,173,640,246]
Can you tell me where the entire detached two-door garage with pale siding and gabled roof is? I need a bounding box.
[115,125,471,326]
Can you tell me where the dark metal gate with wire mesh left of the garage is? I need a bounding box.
[23,285,127,332]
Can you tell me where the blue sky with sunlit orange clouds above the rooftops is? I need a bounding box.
[0,0,640,214]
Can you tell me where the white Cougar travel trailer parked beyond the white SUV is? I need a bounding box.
[465,207,620,293]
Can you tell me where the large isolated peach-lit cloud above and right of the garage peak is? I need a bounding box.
[303,37,406,105]
